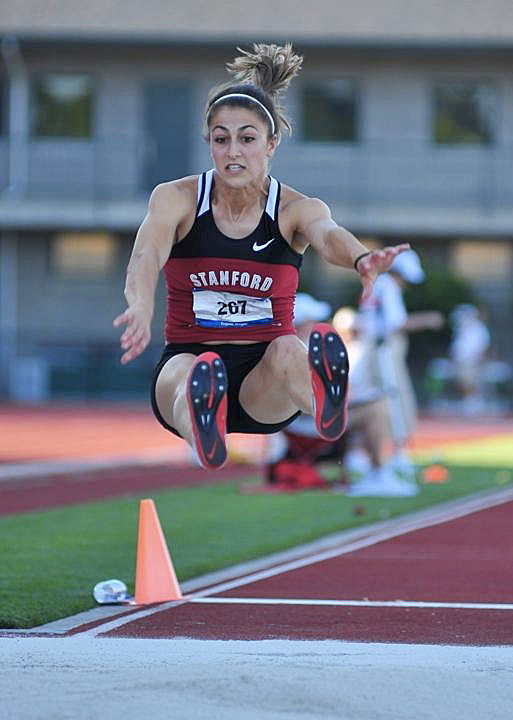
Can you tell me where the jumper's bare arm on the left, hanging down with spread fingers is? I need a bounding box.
[113,181,190,365]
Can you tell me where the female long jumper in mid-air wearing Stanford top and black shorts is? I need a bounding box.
[114,44,409,468]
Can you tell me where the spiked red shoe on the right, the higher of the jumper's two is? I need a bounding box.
[308,323,349,441]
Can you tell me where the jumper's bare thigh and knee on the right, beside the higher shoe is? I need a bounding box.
[239,335,311,424]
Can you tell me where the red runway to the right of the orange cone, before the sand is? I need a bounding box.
[99,501,513,645]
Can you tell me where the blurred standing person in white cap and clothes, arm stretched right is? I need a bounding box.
[360,250,444,479]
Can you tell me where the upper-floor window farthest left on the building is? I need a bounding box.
[32,73,93,138]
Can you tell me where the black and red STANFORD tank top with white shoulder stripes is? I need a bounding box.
[164,170,302,343]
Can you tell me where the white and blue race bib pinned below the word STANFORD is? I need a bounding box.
[192,290,273,327]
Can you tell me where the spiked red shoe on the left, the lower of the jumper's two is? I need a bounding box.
[187,352,228,470]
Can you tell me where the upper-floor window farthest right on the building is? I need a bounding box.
[434,80,498,145]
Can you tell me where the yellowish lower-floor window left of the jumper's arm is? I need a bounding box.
[50,233,118,277]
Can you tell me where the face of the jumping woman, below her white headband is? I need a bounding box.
[210,106,277,187]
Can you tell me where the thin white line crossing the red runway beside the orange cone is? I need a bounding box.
[189,597,513,610]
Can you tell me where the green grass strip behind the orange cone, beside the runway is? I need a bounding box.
[0,467,513,628]
